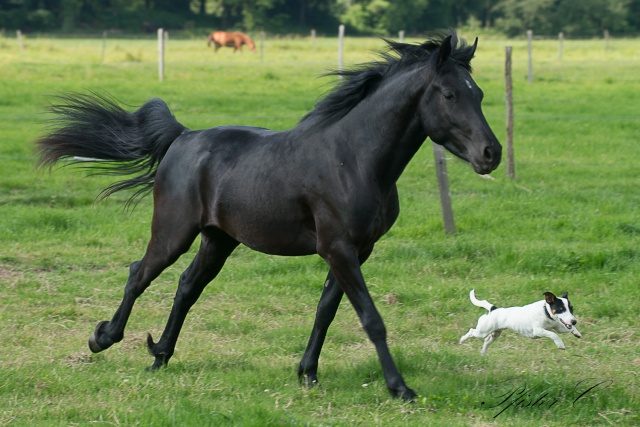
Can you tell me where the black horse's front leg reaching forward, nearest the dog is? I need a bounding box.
[321,241,417,401]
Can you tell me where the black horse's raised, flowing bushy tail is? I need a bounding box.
[36,93,187,208]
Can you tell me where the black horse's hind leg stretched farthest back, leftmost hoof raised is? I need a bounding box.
[89,209,199,353]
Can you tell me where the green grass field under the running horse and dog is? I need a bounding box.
[0,34,640,426]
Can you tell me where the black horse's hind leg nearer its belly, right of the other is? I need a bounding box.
[147,230,238,369]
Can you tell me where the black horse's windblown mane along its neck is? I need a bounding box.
[300,31,475,126]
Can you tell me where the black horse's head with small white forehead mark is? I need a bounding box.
[420,35,502,174]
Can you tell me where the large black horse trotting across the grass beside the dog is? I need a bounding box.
[37,33,501,400]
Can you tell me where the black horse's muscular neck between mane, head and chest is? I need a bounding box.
[339,67,429,184]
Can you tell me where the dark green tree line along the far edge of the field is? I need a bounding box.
[0,0,640,37]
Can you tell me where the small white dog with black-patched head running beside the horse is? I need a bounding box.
[460,289,582,355]
